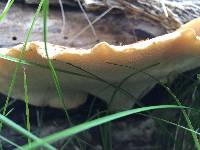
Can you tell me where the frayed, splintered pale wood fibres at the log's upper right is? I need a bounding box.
[23,0,200,33]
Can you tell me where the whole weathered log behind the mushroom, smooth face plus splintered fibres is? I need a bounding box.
[0,0,200,48]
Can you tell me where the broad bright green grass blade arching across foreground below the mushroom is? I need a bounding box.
[23,105,187,150]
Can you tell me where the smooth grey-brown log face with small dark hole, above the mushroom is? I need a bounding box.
[0,2,155,48]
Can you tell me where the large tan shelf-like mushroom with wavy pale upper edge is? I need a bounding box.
[0,18,200,110]
